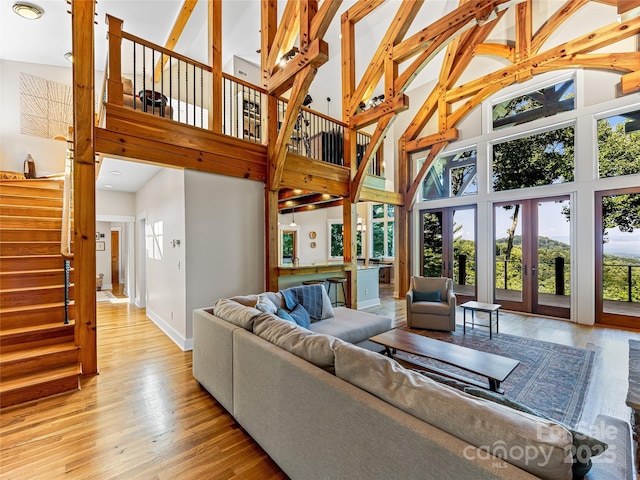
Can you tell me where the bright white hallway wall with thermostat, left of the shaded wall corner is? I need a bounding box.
[135,168,188,349]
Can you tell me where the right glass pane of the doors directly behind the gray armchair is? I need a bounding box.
[453,208,476,297]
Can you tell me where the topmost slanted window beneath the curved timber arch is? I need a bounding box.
[491,79,575,130]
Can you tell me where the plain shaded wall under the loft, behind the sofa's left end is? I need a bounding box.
[185,170,265,339]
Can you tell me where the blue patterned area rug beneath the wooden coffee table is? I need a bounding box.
[398,327,596,426]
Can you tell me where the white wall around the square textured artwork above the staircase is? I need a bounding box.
[0,60,71,176]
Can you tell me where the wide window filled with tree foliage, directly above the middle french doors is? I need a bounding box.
[493,125,575,192]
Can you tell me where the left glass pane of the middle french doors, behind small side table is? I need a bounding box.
[494,203,523,304]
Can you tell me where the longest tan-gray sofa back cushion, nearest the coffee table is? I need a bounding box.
[334,343,572,480]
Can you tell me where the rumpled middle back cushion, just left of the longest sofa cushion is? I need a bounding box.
[254,317,336,372]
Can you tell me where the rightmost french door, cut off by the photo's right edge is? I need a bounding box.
[595,187,640,328]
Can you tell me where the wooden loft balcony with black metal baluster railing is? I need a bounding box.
[96,16,384,208]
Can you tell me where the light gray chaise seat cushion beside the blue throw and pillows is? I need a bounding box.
[309,307,391,344]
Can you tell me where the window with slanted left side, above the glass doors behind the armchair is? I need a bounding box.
[418,148,478,200]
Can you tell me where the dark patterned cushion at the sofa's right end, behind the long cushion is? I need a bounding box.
[464,387,609,480]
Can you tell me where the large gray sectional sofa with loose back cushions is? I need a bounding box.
[193,288,633,480]
